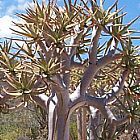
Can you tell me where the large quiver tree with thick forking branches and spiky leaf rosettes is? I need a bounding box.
[0,0,139,140]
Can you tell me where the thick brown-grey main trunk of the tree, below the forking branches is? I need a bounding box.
[50,81,70,140]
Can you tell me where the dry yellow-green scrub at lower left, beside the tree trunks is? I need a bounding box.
[0,109,40,140]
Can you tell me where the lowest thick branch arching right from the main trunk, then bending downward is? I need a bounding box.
[69,92,128,140]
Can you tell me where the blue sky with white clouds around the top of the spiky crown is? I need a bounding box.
[0,0,140,38]
